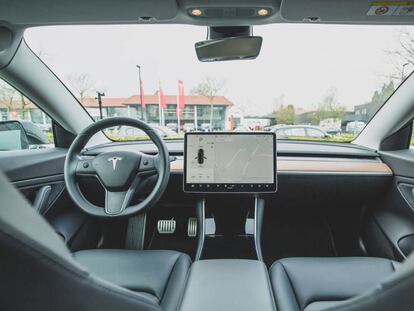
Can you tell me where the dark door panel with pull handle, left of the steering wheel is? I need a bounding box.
[0,148,102,251]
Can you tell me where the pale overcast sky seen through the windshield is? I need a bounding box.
[25,24,414,115]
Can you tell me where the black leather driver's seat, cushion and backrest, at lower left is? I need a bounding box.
[0,172,191,311]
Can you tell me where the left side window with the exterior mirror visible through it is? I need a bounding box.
[0,80,54,151]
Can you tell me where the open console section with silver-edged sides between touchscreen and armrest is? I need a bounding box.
[195,196,265,261]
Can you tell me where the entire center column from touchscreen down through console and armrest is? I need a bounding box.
[175,132,277,311]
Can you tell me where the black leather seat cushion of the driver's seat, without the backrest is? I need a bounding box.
[74,250,191,310]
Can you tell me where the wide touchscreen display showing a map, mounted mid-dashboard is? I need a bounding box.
[184,133,276,192]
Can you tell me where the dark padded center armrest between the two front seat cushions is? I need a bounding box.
[180,259,276,311]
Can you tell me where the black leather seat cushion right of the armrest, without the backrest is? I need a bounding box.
[270,257,398,311]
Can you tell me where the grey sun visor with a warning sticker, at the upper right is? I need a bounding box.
[281,0,414,24]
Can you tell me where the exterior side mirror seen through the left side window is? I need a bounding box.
[0,121,29,151]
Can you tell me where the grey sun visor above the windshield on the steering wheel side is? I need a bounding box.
[0,0,178,25]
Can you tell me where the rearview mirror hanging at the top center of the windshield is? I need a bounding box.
[195,36,262,62]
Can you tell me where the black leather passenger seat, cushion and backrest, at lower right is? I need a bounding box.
[270,257,402,311]
